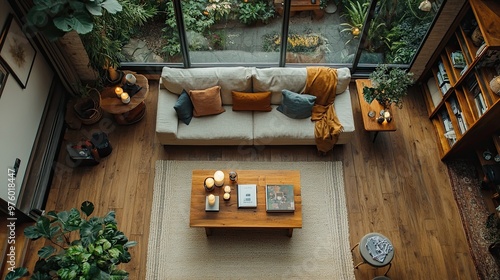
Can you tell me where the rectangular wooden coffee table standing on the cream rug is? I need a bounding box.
[189,170,302,237]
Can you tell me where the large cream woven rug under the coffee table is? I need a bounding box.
[146,161,355,279]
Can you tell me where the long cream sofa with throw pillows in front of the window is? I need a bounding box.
[156,67,355,145]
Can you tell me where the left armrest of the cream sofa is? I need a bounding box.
[156,87,179,145]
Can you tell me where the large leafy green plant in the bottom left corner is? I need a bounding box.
[5,201,136,280]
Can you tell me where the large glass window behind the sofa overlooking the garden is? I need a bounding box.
[124,0,442,67]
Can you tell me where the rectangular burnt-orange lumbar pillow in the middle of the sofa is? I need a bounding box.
[232,91,271,112]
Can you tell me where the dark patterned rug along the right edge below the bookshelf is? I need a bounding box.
[447,160,500,280]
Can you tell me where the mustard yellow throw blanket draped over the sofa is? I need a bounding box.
[304,67,344,153]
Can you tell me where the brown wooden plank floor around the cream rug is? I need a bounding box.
[19,80,477,279]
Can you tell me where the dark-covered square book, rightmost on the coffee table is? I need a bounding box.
[266,185,295,212]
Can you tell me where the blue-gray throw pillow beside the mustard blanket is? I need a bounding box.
[276,89,316,119]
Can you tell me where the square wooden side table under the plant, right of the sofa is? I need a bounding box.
[356,79,396,142]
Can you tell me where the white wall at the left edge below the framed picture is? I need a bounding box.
[0,0,54,205]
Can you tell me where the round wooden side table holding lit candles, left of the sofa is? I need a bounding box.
[101,71,149,125]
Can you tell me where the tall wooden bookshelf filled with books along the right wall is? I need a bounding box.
[422,0,500,160]
